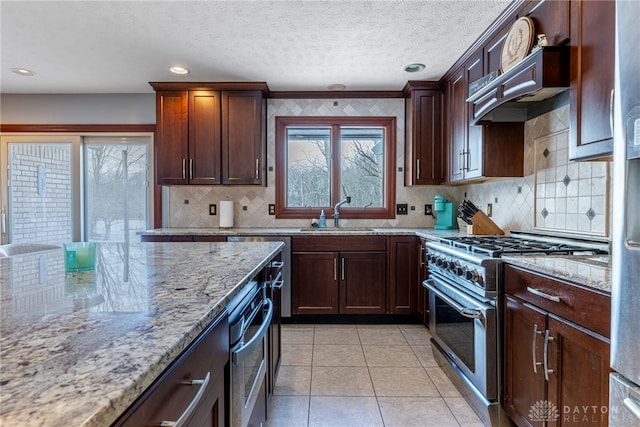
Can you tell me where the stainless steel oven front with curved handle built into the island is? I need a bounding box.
[230,298,273,427]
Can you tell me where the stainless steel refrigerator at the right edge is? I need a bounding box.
[609,0,640,427]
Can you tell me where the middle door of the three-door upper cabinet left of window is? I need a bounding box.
[188,91,221,184]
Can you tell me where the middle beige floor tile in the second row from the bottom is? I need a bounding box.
[311,366,375,396]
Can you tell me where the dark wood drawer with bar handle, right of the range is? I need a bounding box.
[504,265,611,337]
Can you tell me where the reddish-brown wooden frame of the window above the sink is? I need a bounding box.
[275,116,397,219]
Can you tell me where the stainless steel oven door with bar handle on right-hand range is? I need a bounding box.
[423,274,498,401]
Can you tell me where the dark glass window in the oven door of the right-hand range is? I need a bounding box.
[434,295,476,372]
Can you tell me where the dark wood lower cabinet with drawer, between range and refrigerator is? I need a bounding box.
[504,265,610,426]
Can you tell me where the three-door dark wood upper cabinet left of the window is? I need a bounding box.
[151,82,266,185]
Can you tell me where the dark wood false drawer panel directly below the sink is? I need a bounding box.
[291,236,387,252]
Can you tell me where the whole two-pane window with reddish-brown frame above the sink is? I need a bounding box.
[276,117,395,218]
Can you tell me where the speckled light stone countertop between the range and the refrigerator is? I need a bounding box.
[503,255,611,294]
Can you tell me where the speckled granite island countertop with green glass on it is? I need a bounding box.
[0,242,282,427]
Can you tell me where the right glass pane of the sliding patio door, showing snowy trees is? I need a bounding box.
[85,143,148,241]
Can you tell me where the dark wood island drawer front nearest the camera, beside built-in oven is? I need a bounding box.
[114,312,229,427]
